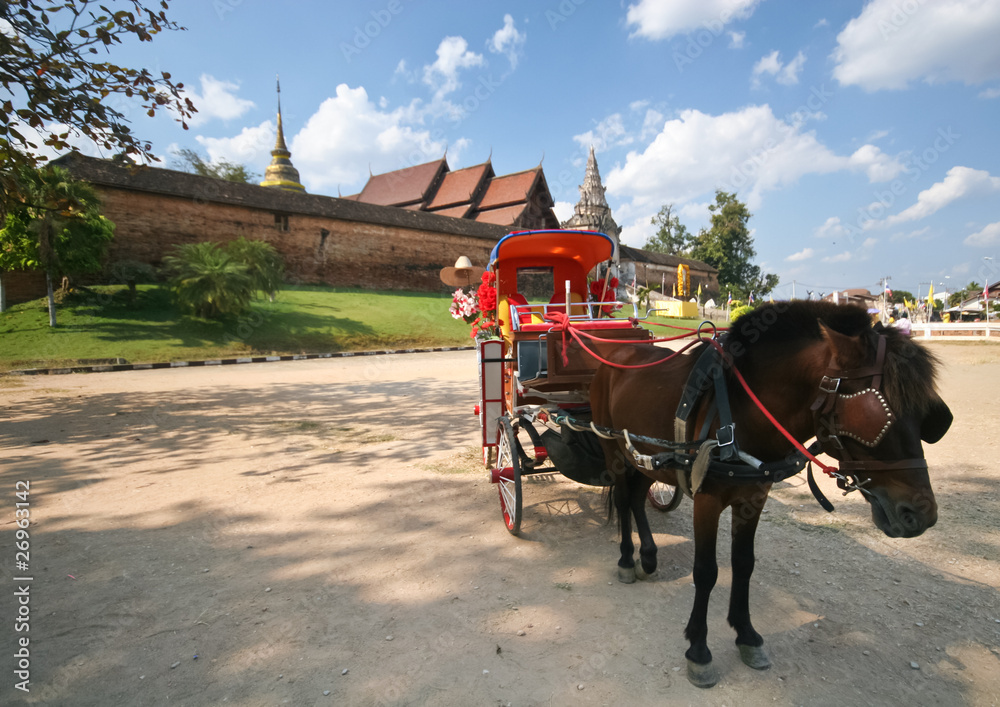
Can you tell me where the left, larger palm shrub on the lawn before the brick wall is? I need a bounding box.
[163,243,255,319]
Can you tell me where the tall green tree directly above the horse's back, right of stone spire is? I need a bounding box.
[691,189,779,300]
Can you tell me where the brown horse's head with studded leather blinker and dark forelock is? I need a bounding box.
[814,323,952,538]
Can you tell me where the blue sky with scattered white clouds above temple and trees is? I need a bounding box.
[21,0,1000,297]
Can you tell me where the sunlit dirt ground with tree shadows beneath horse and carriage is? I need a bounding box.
[0,343,1000,707]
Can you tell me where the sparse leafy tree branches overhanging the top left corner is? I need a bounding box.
[0,0,196,216]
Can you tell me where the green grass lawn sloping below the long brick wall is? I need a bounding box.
[0,285,697,371]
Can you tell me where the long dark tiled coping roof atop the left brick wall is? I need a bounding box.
[54,152,507,241]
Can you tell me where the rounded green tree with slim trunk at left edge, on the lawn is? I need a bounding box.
[0,166,114,326]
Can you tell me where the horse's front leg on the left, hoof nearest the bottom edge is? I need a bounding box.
[684,493,723,687]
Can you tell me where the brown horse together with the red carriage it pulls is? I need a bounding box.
[468,231,952,687]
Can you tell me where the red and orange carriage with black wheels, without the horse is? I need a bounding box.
[477,231,682,535]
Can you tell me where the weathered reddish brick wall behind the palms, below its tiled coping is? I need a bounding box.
[98,187,495,291]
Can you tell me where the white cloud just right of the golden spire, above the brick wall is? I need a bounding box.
[286,84,450,194]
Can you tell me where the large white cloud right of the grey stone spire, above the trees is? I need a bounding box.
[606,105,904,217]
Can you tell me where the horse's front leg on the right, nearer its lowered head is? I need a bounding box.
[728,484,771,670]
